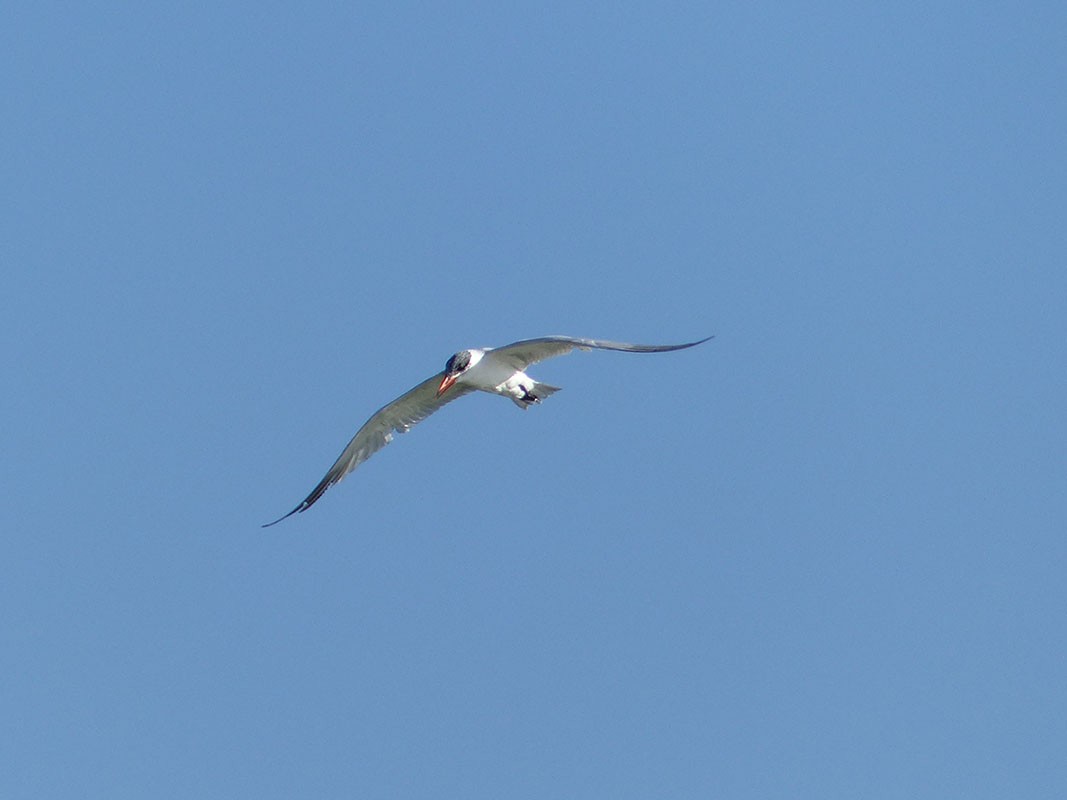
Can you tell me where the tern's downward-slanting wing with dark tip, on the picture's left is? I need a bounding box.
[262,372,473,528]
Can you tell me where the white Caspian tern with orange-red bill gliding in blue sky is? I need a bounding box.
[262,336,712,528]
